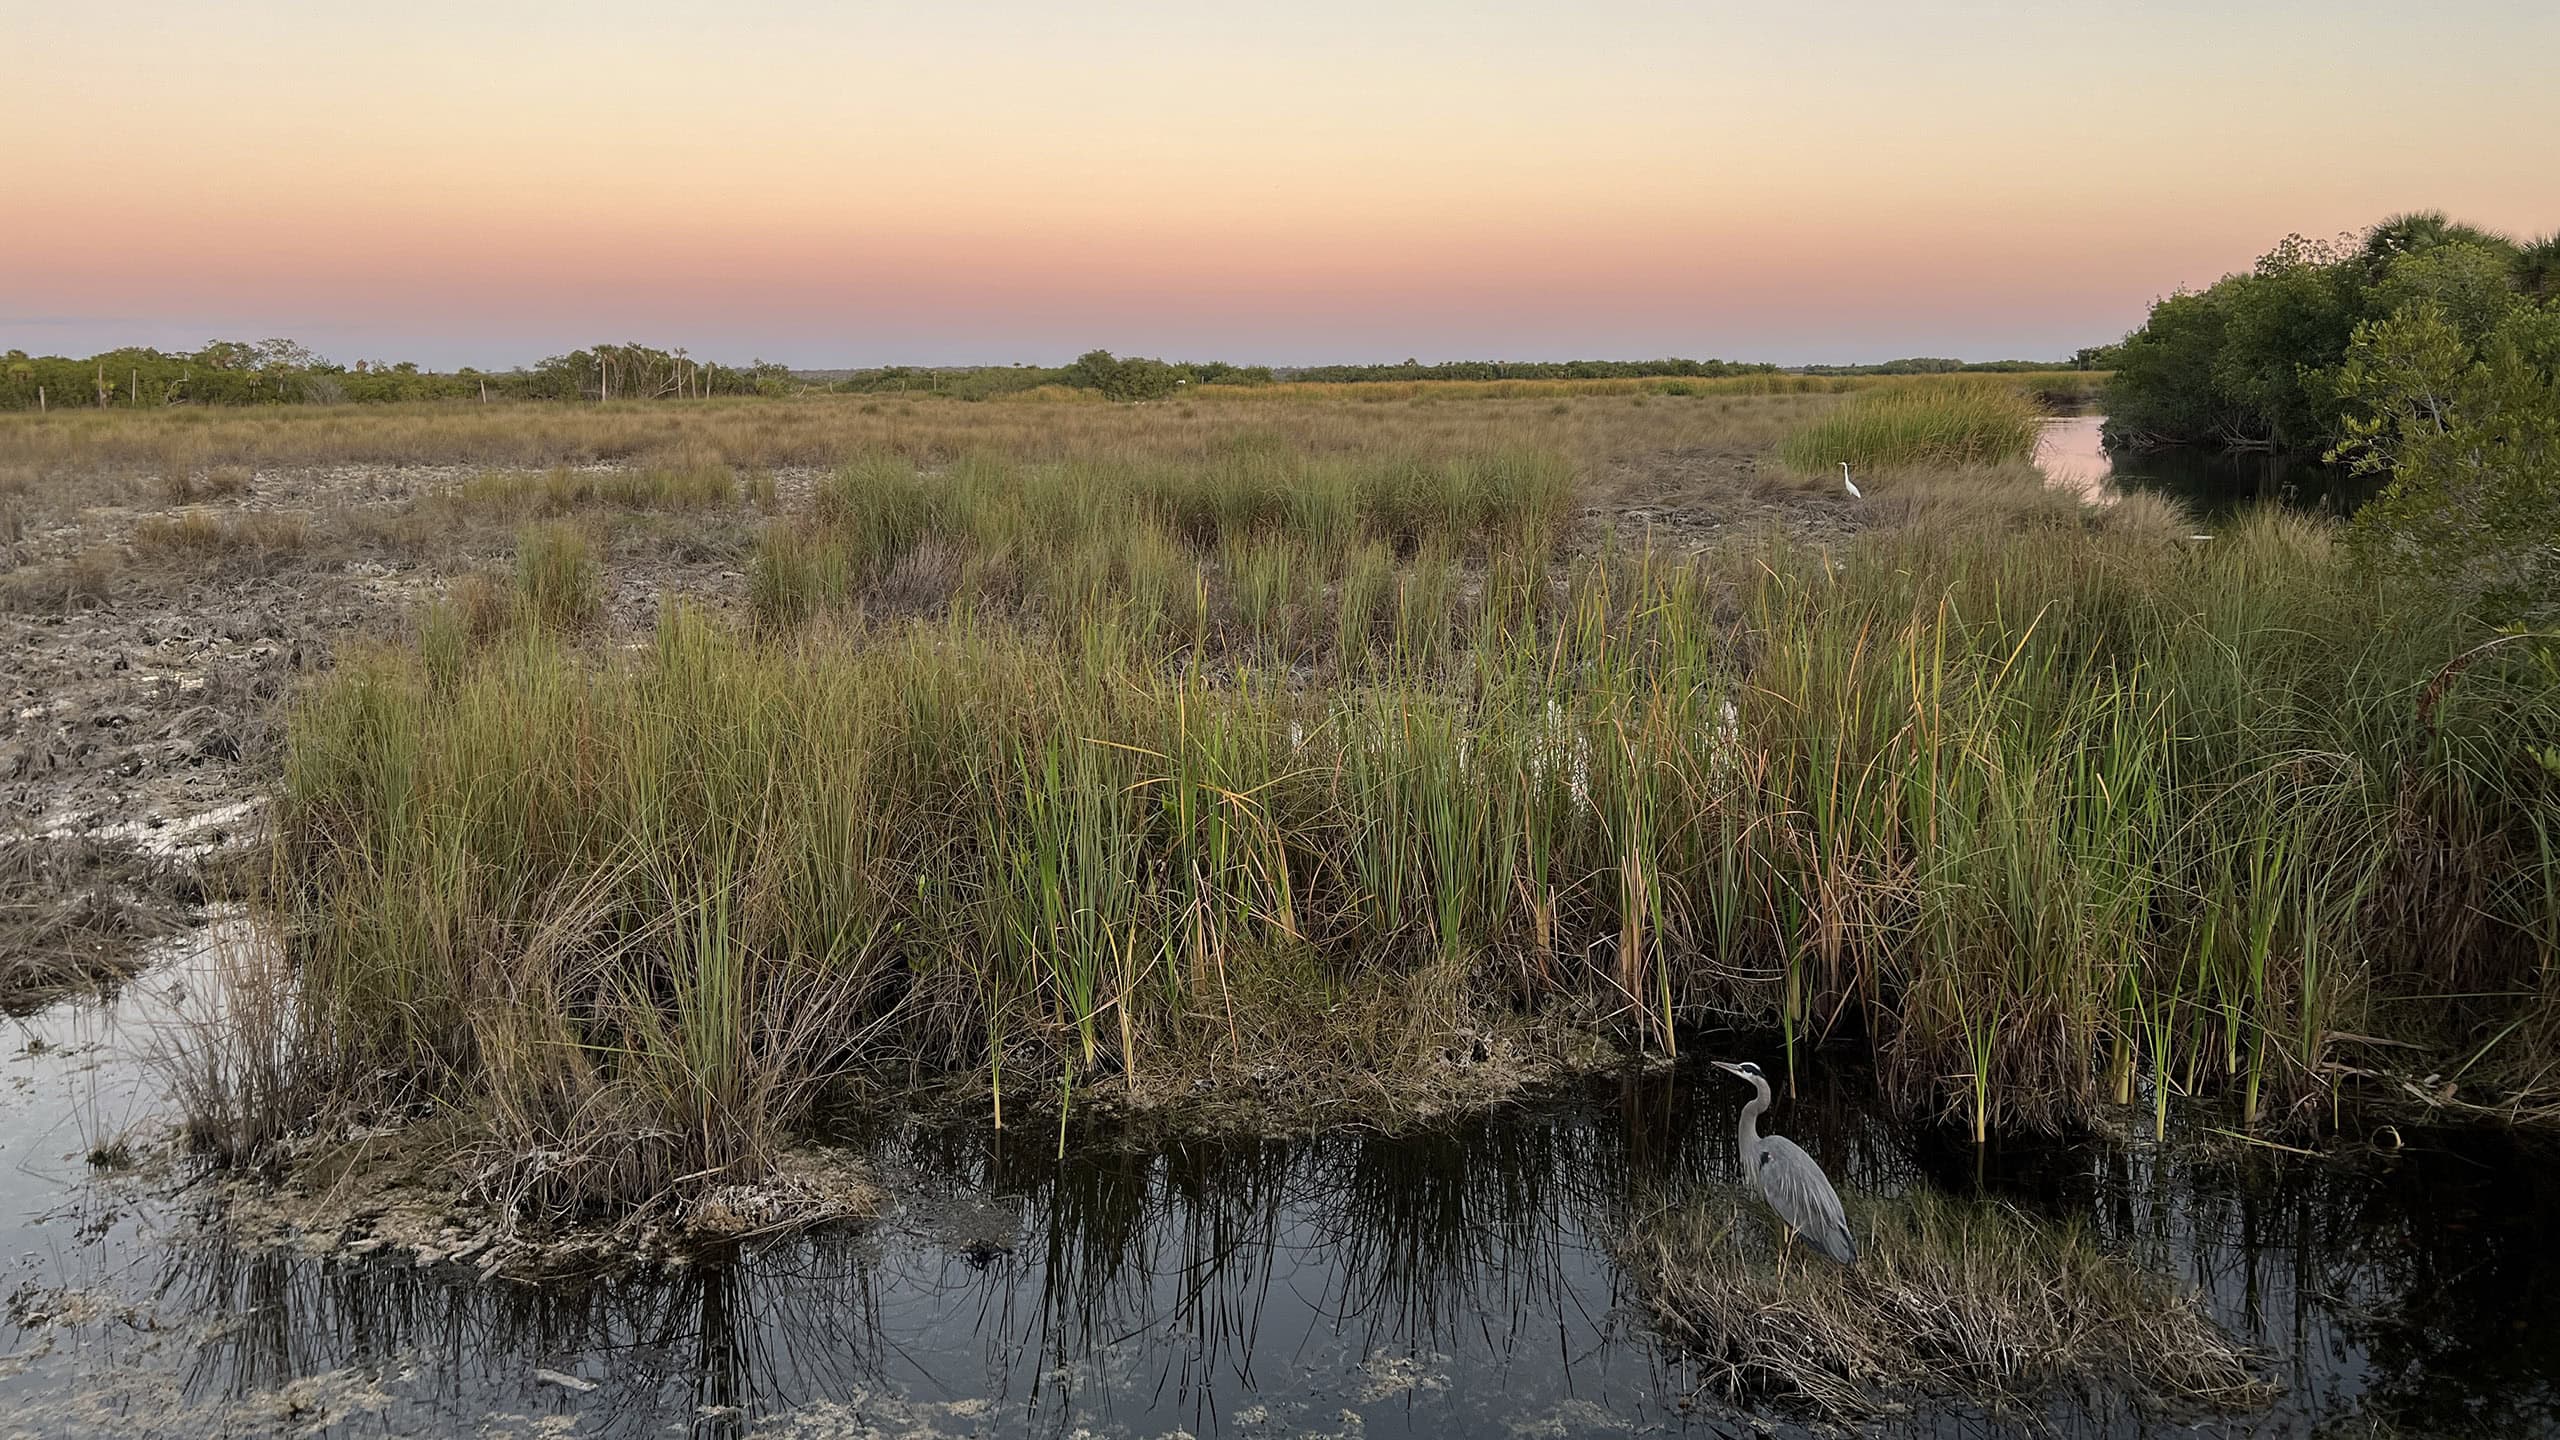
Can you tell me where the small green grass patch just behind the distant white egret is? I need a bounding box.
[1777,379,2040,471]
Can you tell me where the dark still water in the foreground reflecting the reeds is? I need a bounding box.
[0,922,2560,1440]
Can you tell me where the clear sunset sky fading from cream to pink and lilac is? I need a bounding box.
[0,0,2560,366]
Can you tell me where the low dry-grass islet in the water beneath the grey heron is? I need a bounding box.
[1620,1189,2276,1422]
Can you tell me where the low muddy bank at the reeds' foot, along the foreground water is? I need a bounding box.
[199,973,1638,1281]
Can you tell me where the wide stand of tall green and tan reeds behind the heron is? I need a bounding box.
[235,466,2560,1207]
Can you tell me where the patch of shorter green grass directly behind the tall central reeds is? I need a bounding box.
[750,443,1572,666]
